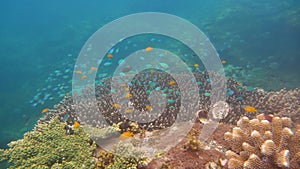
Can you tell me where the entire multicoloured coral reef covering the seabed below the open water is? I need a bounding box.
[7,69,300,168]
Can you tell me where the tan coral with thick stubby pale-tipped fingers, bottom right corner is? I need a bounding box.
[224,114,300,169]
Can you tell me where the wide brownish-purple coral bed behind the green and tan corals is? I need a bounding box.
[39,71,300,131]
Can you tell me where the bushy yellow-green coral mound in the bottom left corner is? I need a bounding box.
[0,118,96,169]
